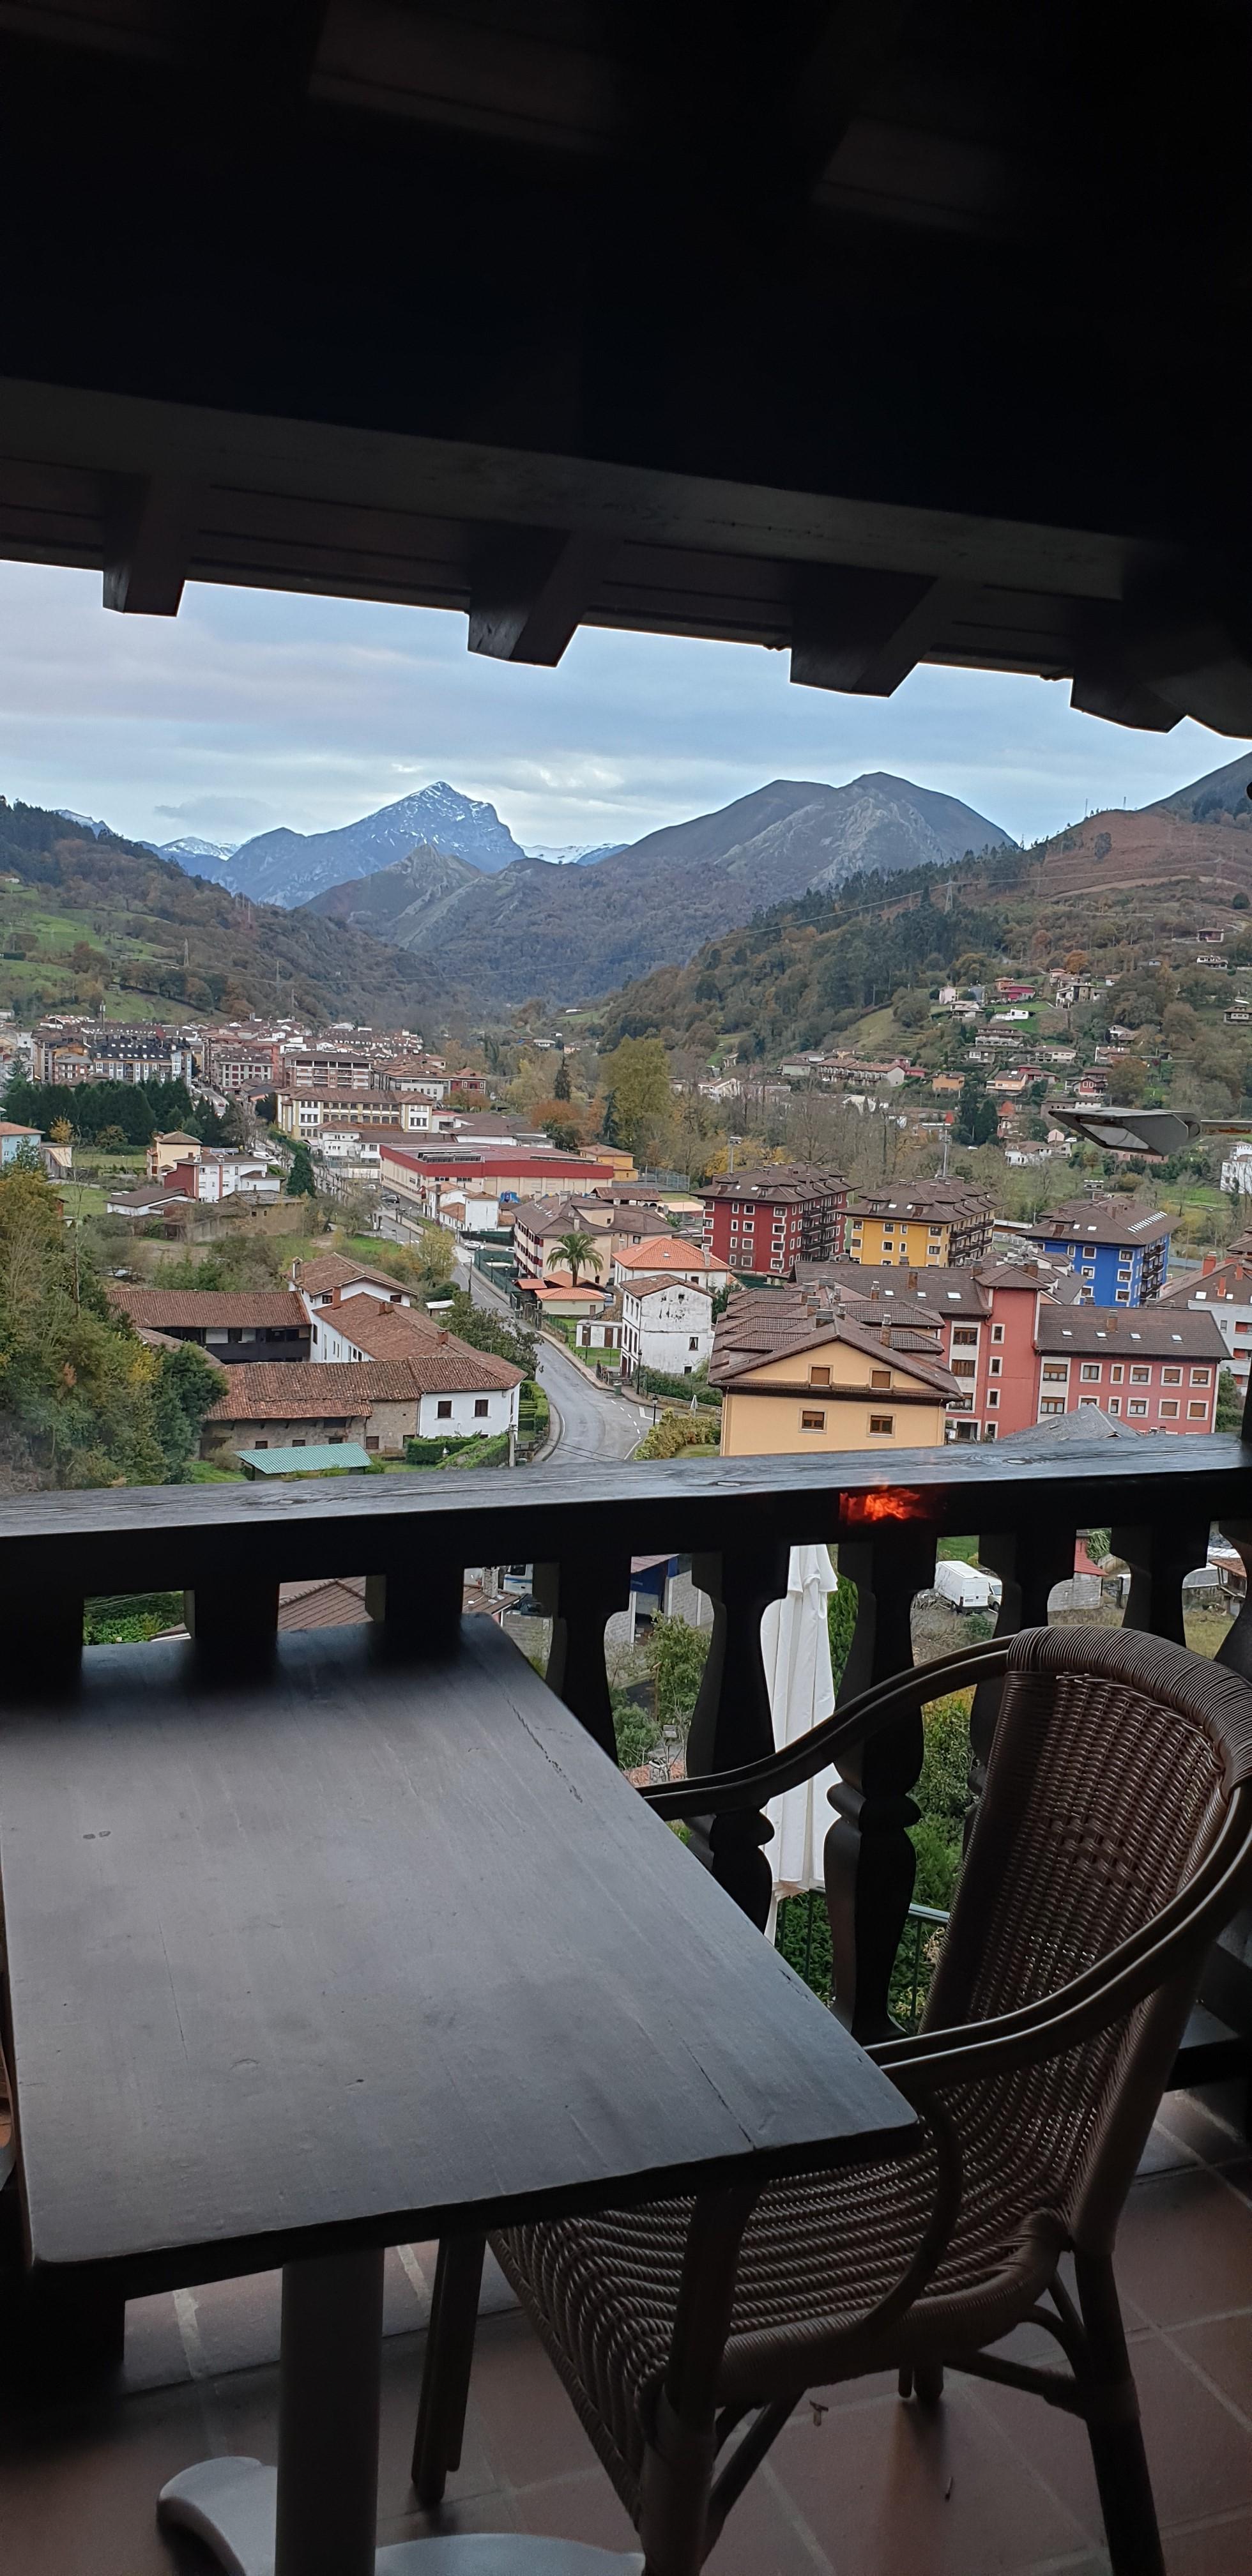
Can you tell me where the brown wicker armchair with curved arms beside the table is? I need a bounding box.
[412,1628,1252,2576]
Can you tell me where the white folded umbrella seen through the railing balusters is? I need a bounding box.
[760,1548,840,1929]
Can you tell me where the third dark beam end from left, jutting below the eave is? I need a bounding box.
[791,564,968,698]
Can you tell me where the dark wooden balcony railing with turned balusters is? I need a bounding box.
[0,1438,1252,2037]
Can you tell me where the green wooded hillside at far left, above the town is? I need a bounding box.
[0,799,446,1031]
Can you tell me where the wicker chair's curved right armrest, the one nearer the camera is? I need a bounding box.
[866,1780,1252,2102]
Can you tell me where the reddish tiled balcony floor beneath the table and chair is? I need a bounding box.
[0,2094,1252,2576]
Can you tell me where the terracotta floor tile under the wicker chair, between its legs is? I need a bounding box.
[770,2388,1090,2576]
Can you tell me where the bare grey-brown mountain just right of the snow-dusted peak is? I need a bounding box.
[309,773,1007,1002]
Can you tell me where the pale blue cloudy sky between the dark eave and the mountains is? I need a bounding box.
[0,564,1244,845]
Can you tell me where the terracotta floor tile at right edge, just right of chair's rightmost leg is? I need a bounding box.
[1115,2169,1252,2326]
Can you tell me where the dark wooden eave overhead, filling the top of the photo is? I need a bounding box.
[0,0,1252,734]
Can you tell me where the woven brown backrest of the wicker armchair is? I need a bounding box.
[922,1628,1252,2249]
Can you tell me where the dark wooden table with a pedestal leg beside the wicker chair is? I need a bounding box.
[0,1620,915,2576]
